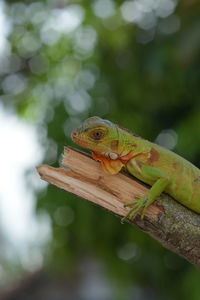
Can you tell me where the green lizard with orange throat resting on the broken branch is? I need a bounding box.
[71,117,200,220]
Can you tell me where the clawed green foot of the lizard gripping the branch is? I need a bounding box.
[122,196,148,222]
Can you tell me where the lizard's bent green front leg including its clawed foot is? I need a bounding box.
[122,165,170,221]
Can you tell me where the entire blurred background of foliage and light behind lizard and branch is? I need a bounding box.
[0,0,200,300]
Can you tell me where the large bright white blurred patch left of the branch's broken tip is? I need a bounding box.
[0,105,51,268]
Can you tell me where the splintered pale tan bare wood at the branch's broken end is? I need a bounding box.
[37,147,160,216]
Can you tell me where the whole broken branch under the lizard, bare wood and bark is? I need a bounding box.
[37,147,200,267]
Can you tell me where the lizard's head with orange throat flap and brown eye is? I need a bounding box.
[71,117,124,174]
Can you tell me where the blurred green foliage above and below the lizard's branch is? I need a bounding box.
[1,0,200,300]
